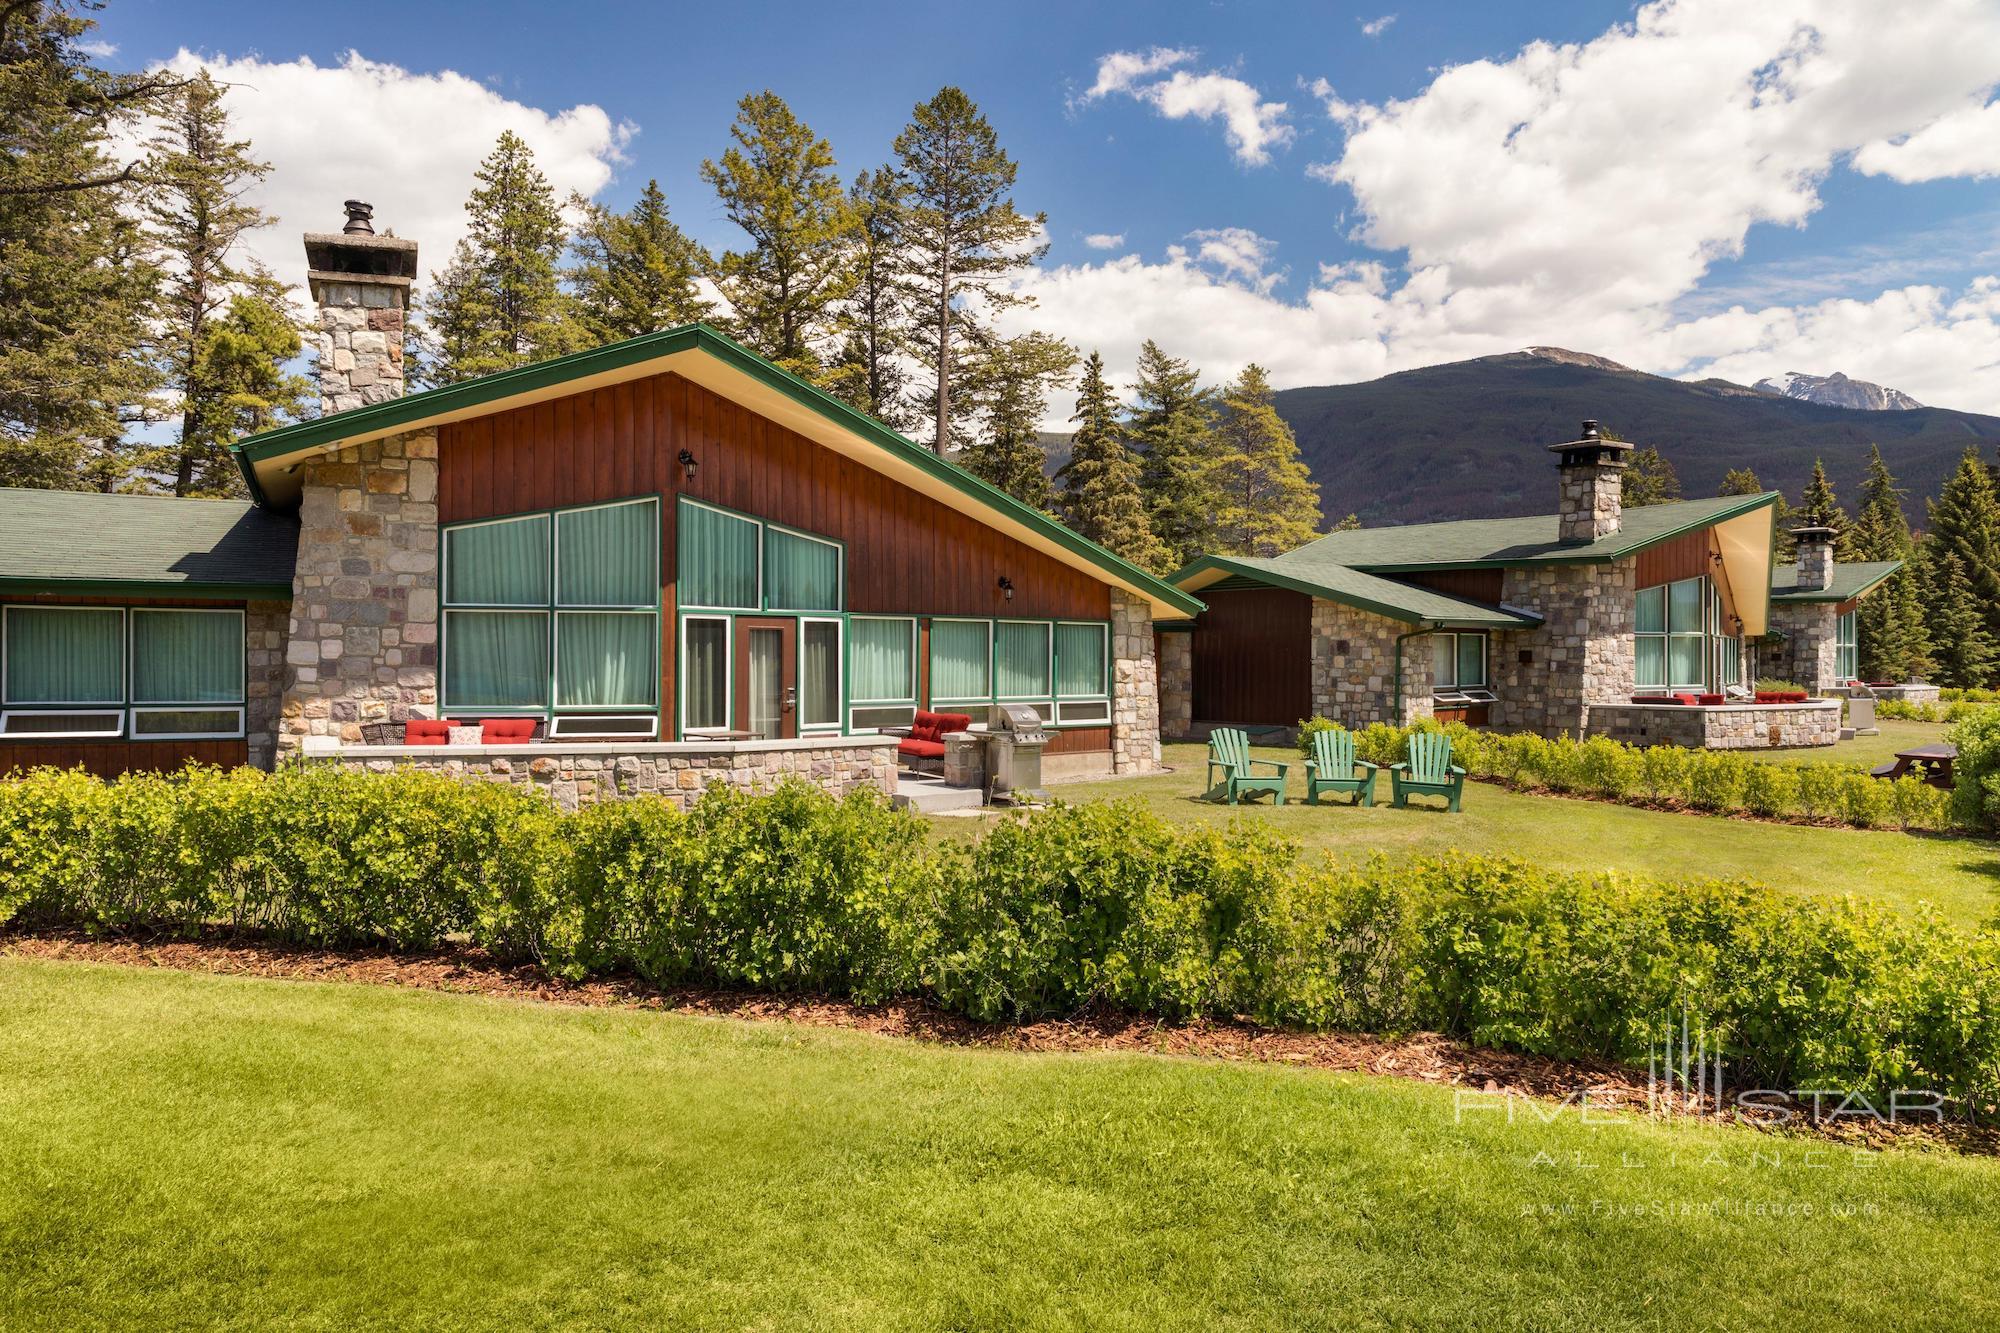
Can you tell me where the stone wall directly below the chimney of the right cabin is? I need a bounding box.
[1486,560,1638,737]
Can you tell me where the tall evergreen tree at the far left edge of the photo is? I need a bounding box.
[0,4,169,490]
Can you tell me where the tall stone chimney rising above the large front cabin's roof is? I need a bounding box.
[306,198,416,414]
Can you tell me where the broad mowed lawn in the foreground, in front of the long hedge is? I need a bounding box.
[11,959,2000,1331]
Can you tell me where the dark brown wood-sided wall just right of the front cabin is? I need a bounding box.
[1192,588,1312,727]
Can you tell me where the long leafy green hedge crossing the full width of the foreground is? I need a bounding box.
[0,767,2000,1111]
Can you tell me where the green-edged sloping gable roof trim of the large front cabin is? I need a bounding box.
[230,324,1202,614]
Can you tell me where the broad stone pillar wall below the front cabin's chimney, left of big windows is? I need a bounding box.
[278,430,438,755]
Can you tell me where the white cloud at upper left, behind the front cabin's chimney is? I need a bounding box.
[149,50,634,294]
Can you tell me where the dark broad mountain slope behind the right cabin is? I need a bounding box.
[1278,348,2000,524]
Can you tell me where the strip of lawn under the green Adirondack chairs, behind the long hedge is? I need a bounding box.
[1008,736,2000,925]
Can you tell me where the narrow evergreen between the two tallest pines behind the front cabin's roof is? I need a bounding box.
[826,166,916,432]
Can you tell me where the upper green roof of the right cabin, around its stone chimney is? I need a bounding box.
[1276,490,1778,572]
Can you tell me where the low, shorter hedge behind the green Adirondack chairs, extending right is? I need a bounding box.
[1300,719,1952,829]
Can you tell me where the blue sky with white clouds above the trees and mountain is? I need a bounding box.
[98,0,2000,410]
